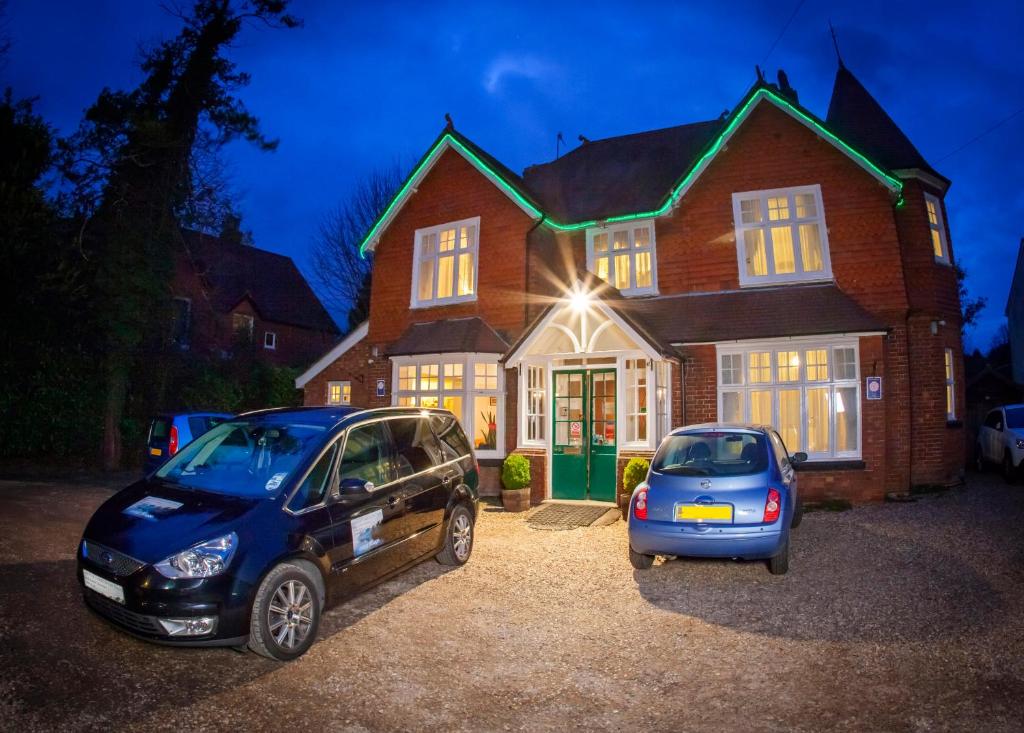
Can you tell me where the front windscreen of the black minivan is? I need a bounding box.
[151,420,325,497]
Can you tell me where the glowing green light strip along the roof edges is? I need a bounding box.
[359,87,903,257]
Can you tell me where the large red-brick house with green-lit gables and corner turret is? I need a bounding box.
[296,67,965,502]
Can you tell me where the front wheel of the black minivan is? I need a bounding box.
[249,563,323,661]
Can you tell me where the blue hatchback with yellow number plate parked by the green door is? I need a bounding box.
[629,424,807,574]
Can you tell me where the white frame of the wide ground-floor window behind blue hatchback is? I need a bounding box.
[715,337,864,461]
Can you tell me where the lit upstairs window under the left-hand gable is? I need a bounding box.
[412,217,480,308]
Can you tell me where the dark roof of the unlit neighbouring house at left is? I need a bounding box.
[181,229,338,334]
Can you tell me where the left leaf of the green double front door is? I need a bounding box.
[551,372,587,499]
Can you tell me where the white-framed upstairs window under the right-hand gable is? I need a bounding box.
[732,185,831,286]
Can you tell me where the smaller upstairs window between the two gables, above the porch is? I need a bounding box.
[587,221,657,295]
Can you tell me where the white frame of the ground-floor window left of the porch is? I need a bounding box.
[391,353,506,459]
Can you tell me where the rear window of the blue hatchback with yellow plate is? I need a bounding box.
[651,431,768,476]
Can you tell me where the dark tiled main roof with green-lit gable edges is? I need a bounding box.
[359,81,903,256]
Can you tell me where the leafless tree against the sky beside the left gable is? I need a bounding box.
[313,163,406,331]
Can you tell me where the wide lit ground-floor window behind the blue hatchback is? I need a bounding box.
[718,339,860,459]
